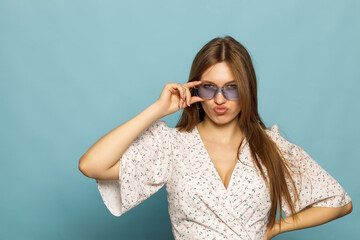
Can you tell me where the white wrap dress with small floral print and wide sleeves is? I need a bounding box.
[96,120,351,240]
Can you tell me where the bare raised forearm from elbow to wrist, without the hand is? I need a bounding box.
[79,102,163,179]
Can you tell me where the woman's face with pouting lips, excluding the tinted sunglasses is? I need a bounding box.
[200,62,241,124]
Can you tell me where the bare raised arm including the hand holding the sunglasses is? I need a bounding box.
[79,81,204,180]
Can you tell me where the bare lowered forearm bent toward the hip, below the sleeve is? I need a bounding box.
[267,202,353,239]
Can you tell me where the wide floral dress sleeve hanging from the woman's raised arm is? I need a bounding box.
[96,120,172,216]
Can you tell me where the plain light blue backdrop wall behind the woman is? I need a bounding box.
[0,0,360,240]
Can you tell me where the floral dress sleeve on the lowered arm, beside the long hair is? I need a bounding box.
[268,124,351,216]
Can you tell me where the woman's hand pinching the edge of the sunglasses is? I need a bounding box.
[156,81,204,116]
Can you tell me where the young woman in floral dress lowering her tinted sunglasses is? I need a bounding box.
[79,36,352,239]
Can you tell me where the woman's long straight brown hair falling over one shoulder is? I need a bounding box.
[176,36,299,231]
